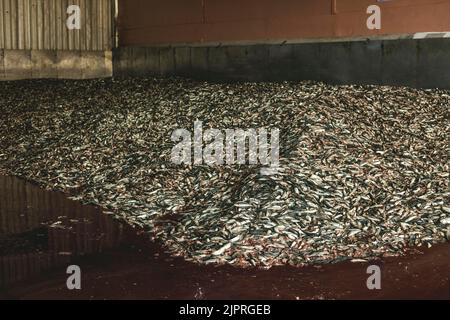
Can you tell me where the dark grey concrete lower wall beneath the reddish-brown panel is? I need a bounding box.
[113,38,450,88]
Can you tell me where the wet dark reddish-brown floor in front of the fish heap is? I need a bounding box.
[0,176,450,300]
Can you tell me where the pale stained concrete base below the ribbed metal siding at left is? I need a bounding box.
[0,50,112,80]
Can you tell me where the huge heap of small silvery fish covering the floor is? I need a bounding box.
[0,79,450,267]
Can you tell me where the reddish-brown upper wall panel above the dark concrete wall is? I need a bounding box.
[119,0,450,46]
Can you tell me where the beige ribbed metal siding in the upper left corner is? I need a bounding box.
[0,0,114,51]
